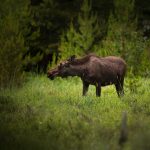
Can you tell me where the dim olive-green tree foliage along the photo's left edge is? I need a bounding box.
[0,0,28,87]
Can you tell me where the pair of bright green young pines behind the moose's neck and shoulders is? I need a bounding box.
[59,0,100,57]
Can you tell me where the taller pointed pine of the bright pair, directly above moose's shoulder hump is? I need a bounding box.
[78,0,100,53]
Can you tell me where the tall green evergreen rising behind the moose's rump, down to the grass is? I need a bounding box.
[103,0,145,74]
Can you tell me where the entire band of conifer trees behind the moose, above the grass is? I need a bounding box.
[0,0,150,79]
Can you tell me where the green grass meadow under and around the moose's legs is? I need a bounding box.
[0,75,150,150]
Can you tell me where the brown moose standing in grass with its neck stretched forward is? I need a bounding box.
[47,54,126,97]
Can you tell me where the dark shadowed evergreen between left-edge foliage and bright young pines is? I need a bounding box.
[25,0,70,72]
